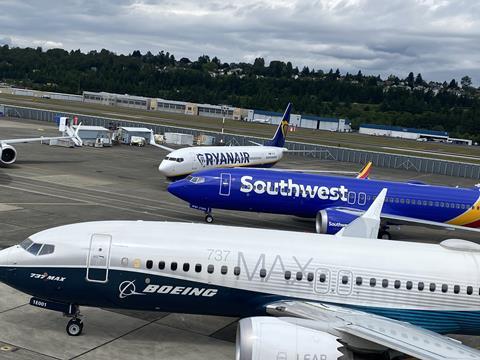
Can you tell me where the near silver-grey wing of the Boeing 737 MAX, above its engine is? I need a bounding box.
[267,301,480,360]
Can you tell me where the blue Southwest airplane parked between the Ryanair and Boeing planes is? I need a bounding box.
[168,168,480,238]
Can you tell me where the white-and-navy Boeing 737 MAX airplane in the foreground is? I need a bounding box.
[0,189,480,360]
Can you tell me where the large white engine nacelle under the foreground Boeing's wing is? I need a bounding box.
[235,316,352,360]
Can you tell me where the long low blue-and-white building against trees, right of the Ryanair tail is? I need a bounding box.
[359,124,448,142]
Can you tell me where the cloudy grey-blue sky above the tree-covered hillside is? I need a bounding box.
[0,0,480,86]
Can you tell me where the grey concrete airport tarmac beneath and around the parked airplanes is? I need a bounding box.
[0,119,480,360]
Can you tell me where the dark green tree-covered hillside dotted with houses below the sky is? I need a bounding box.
[0,45,480,142]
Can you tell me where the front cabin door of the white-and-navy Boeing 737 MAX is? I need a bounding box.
[86,234,112,283]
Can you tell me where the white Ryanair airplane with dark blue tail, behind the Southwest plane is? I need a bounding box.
[156,103,296,180]
